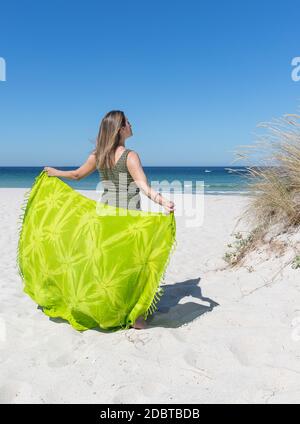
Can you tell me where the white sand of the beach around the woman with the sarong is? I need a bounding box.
[0,188,300,404]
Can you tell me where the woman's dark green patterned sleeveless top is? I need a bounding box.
[98,149,141,210]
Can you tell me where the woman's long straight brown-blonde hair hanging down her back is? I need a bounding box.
[94,110,126,169]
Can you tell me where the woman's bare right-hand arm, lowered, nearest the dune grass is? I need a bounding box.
[127,150,175,212]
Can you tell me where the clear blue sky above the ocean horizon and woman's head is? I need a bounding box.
[0,0,300,167]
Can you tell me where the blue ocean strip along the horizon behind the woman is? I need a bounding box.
[0,166,253,195]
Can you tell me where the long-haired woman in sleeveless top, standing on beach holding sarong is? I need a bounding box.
[44,110,175,329]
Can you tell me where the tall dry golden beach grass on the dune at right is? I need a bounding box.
[227,114,300,264]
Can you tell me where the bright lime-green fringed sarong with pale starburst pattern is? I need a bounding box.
[17,170,177,331]
